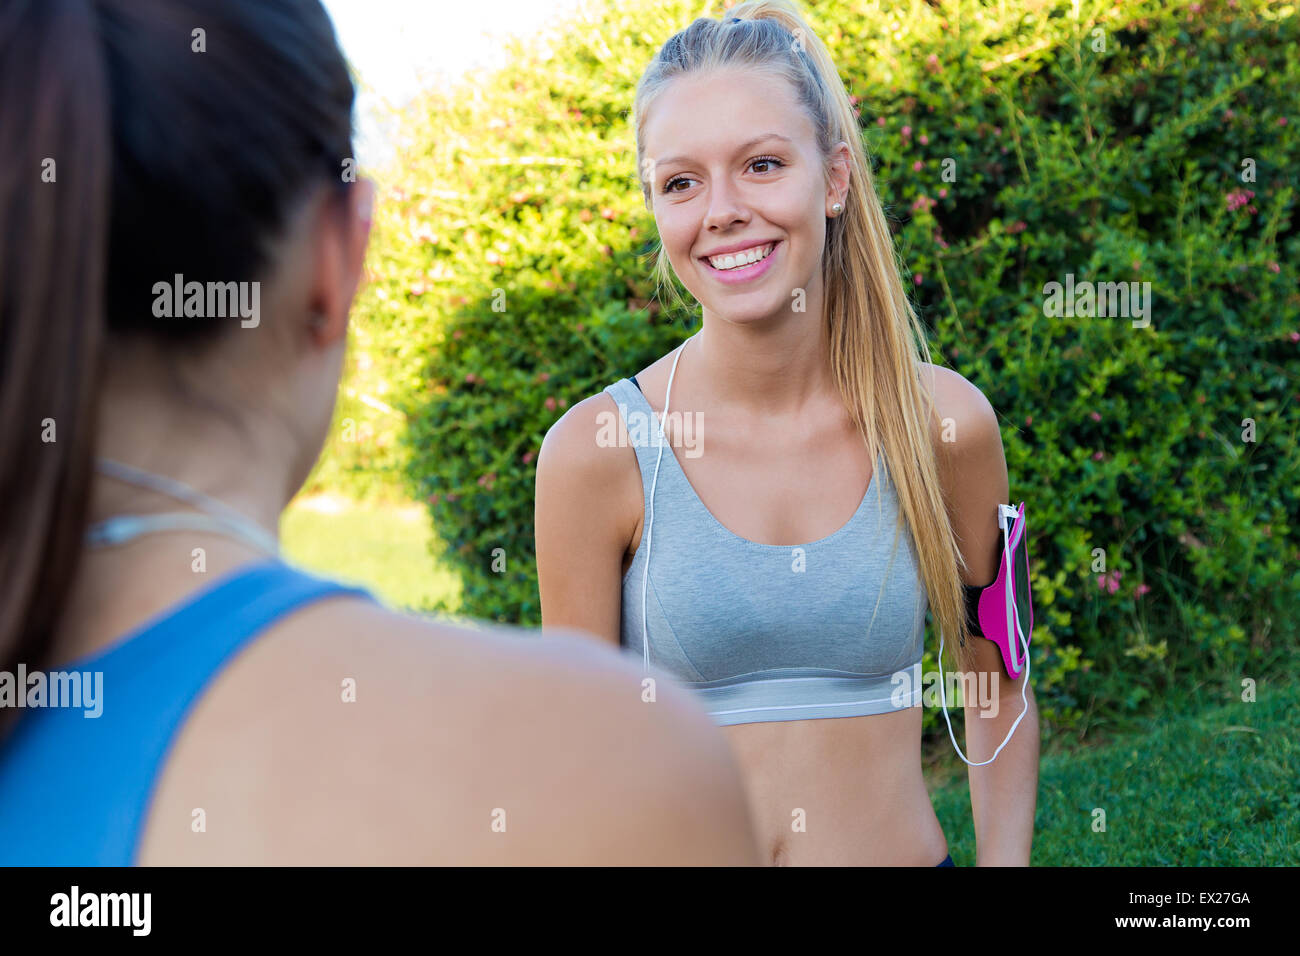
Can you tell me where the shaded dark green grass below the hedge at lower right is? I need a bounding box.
[932,671,1300,866]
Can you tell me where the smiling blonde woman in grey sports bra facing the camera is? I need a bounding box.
[537,0,1039,866]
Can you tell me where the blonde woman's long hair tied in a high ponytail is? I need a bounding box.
[633,0,975,671]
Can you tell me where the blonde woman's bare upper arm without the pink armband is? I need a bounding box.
[534,393,641,645]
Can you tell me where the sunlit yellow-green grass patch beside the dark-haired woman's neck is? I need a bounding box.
[280,494,460,610]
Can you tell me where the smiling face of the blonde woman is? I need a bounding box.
[642,70,848,323]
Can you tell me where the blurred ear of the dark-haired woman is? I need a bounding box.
[308,178,374,347]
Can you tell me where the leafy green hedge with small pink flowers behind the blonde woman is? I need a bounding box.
[358,0,1300,728]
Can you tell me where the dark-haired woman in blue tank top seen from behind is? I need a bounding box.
[0,0,754,865]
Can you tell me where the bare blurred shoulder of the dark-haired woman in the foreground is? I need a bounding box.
[140,598,749,864]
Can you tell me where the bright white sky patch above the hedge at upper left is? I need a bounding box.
[322,0,582,166]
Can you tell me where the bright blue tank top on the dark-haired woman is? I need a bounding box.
[0,561,373,866]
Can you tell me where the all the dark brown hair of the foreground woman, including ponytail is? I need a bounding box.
[0,0,354,717]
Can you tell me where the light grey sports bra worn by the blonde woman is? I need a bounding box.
[605,378,930,726]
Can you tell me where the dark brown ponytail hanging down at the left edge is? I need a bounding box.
[0,0,111,697]
